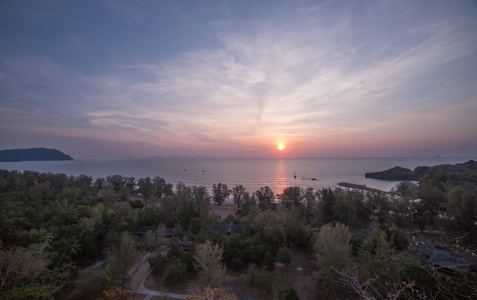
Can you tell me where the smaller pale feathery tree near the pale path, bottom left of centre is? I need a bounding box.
[194,240,226,287]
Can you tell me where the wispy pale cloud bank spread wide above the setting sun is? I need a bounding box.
[0,2,477,159]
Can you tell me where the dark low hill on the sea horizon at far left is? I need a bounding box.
[0,148,73,162]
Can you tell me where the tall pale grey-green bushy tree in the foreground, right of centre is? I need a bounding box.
[315,223,351,298]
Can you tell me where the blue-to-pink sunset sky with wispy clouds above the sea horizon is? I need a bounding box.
[0,0,477,159]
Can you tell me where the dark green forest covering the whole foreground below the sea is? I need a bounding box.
[0,161,477,299]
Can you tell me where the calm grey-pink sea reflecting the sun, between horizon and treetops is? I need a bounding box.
[0,157,477,194]
